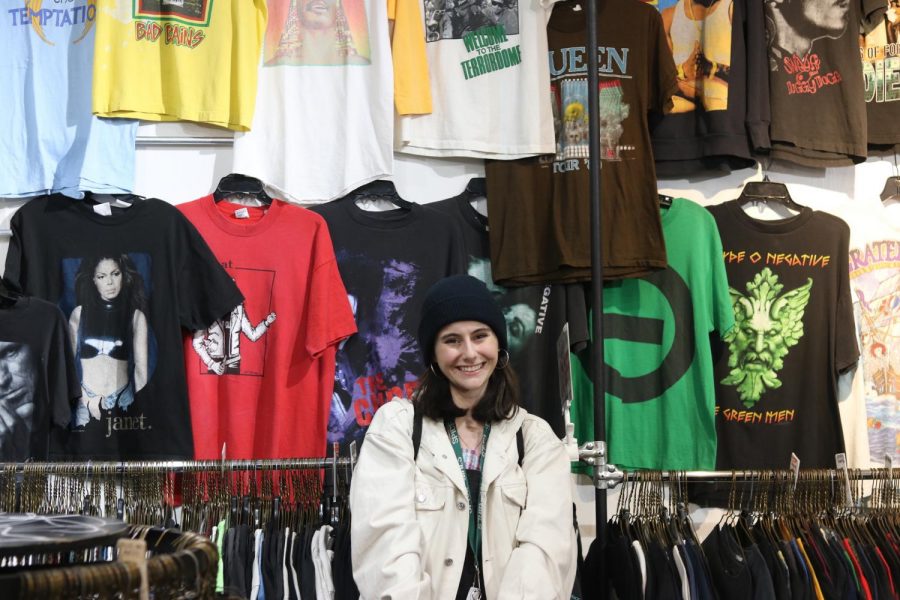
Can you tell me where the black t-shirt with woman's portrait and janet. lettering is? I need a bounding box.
[3,195,243,460]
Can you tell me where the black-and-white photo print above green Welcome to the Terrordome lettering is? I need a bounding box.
[422,0,519,42]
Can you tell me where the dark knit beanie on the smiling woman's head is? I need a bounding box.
[419,275,507,365]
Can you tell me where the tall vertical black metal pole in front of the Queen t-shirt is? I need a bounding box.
[586,0,608,595]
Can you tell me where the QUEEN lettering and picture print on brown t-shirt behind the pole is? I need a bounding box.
[539,46,634,173]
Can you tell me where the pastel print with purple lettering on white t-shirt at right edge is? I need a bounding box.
[850,240,900,462]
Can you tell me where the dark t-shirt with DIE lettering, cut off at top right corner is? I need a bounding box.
[859,0,900,146]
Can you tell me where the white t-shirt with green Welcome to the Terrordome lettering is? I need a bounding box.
[394,0,555,159]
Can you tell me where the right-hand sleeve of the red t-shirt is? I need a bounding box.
[304,215,356,357]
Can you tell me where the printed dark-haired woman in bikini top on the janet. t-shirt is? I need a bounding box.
[69,254,149,427]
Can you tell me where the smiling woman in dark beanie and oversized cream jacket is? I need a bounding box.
[350,275,576,600]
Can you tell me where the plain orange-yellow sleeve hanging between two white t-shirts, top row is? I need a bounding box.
[387,0,431,115]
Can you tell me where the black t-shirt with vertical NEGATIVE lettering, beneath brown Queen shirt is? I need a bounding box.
[425,193,588,438]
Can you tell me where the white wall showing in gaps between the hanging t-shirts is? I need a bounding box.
[0,123,897,540]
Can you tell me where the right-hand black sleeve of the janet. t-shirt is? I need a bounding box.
[175,212,244,331]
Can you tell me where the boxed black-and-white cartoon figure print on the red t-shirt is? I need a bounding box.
[191,260,276,377]
